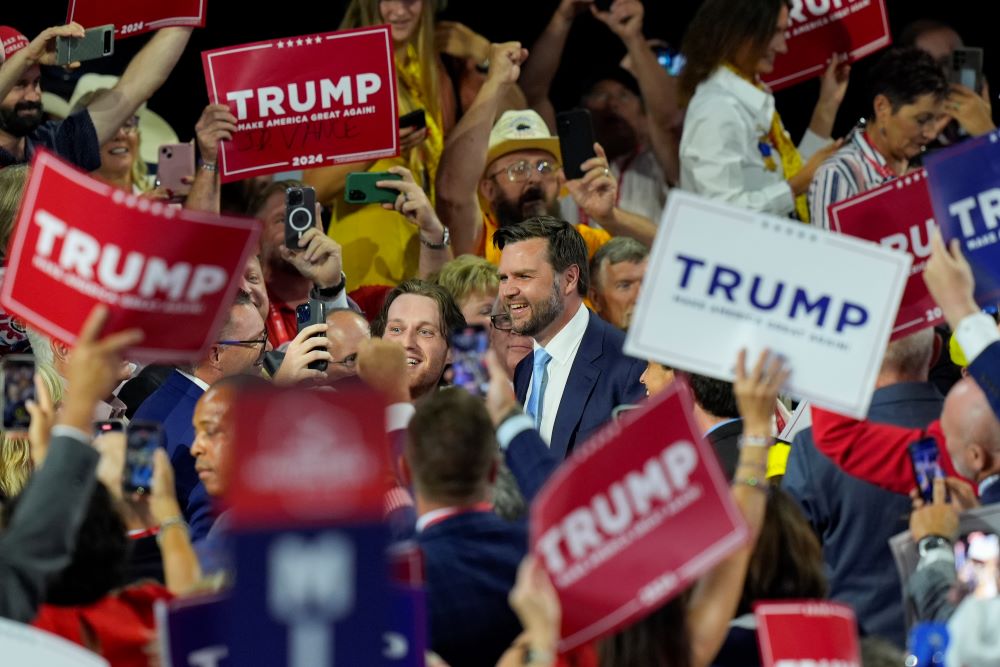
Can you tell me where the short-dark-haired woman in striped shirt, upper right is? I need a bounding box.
[809,48,993,228]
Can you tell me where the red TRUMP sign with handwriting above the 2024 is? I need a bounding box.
[202,26,399,182]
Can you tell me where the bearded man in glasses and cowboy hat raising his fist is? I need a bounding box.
[437,42,656,263]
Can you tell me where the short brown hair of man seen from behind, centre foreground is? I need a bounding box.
[405,387,499,503]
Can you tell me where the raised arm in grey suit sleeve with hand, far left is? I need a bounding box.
[0,307,142,623]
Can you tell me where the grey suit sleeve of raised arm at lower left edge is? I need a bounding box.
[0,435,99,623]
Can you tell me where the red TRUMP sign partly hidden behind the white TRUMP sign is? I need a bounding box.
[828,169,944,340]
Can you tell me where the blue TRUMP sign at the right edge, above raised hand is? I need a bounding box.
[925,132,1000,306]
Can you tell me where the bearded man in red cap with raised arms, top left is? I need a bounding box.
[0,23,191,171]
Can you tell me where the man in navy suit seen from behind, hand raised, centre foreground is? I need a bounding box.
[401,357,558,667]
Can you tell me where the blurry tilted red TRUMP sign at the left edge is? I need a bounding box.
[0,151,259,362]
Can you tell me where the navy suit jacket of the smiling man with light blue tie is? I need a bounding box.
[514,312,646,459]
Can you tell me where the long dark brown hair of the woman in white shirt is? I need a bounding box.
[678,0,791,106]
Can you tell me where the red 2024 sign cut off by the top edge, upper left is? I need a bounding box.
[66,0,208,39]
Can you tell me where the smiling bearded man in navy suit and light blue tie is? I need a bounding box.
[493,217,646,458]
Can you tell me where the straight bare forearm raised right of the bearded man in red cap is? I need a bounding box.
[87,27,191,144]
